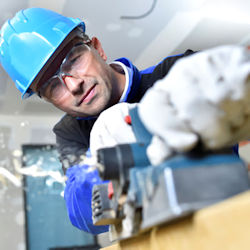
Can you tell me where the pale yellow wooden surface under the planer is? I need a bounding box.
[102,191,250,250]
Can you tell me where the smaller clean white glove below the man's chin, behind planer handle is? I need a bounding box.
[90,103,137,155]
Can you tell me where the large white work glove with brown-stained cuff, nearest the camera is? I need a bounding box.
[138,46,250,164]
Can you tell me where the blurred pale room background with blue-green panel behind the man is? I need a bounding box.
[0,0,250,250]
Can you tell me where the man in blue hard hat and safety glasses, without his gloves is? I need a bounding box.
[0,8,193,234]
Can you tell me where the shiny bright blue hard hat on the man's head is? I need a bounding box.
[0,8,85,98]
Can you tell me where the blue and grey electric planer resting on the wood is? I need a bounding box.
[92,107,249,240]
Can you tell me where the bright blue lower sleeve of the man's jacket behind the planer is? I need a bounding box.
[64,165,108,234]
